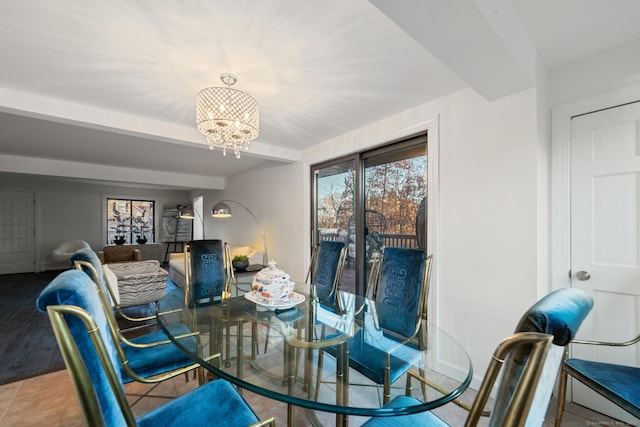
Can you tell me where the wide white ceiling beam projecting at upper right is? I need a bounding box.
[369,0,537,100]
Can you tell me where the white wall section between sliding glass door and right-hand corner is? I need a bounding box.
[420,89,538,387]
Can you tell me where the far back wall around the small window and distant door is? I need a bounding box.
[0,175,189,270]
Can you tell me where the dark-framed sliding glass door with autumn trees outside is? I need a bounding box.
[311,134,427,294]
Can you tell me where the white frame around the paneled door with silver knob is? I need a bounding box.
[549,86,640,290]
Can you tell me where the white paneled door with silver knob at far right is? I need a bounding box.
[571,102,640,425]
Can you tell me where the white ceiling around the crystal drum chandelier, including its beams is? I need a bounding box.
[0,0,640,187]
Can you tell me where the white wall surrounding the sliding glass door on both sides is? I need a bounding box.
[225,85,539,387]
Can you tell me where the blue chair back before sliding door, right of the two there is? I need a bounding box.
[372,247,428,337]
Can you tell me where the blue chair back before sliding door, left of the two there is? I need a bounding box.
[311,240,345,305]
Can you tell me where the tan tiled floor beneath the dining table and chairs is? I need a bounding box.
[0,371,620,427]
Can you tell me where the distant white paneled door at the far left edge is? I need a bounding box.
[0,191,35,274]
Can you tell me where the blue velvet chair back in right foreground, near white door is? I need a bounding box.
[490,288,593,425]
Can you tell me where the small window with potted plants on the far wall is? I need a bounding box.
[107,199,155,245]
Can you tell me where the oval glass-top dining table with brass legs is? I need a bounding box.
[157,284,473,426]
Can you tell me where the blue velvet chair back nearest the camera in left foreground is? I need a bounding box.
[36,270,126,426]
